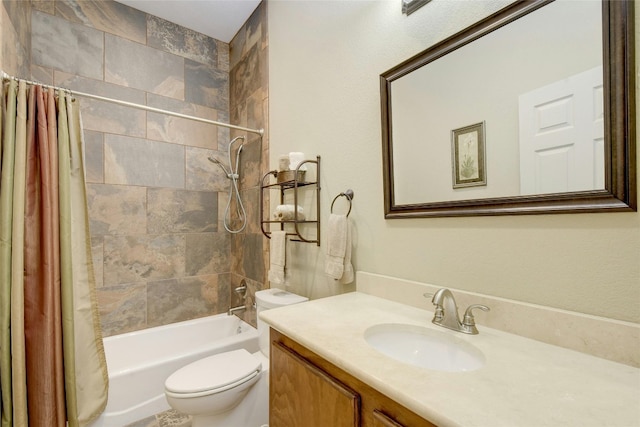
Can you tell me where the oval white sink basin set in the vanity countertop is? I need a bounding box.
[364,323,485,372]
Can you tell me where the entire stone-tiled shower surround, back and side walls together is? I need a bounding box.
[1,0,268,336]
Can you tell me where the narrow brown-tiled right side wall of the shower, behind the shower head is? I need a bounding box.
[230,3,269,325]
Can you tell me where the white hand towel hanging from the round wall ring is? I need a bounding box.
[324,214,353,284]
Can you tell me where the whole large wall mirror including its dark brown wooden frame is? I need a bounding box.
[380,0,637,218]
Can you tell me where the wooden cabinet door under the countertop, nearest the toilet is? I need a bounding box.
[269,342,360,427]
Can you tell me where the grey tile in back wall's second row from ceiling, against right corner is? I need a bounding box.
[184,59,229,111]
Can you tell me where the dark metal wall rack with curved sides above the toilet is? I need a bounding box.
[260,156,320,246]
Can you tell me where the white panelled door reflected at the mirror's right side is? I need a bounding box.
[519,67,604,194]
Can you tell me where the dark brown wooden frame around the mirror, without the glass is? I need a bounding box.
[380,0,637,219]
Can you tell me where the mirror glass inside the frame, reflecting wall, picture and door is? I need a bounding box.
[390,0,605,205]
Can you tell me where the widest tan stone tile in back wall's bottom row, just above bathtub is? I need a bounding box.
[147,275,218,326]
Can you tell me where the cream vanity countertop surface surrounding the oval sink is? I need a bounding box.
[260,292,640,427]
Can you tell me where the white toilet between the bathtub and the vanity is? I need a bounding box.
[164,288,308,427]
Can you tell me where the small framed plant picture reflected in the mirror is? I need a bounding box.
[451,122,487,188]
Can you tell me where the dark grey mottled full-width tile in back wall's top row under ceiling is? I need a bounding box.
[147,15,218,66]
